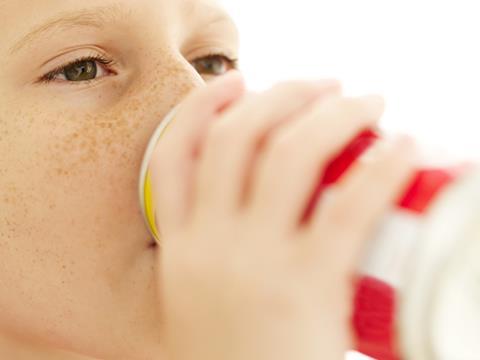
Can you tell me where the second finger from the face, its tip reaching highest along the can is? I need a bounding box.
[191,81,340,219]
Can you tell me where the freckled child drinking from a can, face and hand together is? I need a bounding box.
[0,0,412,360]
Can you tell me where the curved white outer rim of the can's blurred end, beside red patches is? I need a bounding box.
[398,168,480,359]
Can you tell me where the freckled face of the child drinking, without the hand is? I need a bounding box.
[0,0,237,359]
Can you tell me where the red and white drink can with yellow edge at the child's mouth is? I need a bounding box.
[139,109,480,360]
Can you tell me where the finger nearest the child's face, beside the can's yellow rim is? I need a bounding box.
[150,71,245,236]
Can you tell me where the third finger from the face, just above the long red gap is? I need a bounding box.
[251,96,383,229]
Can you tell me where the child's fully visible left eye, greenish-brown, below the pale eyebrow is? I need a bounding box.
[41,56,112,83]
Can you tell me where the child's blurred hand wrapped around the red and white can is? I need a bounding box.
[150,72,412,360]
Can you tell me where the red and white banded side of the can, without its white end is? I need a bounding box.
[302,130,463,360]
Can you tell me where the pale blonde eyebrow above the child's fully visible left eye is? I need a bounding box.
[10,5,123,54]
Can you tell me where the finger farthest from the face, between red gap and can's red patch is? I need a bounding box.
[305,136,415,270]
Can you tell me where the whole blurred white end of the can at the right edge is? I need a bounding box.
[399,168,480,359]
